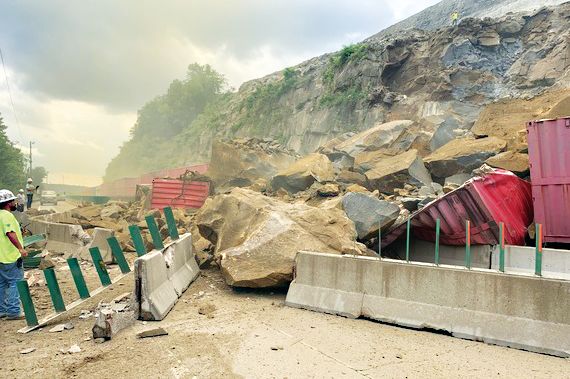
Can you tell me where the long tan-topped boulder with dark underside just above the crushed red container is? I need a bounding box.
[424,137,507,181]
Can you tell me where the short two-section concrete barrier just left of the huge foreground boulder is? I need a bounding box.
[134,233,200,320]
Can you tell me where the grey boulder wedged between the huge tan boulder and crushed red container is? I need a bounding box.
[342,192,400,240]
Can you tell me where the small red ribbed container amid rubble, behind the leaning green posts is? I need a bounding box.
[151,179,210,209]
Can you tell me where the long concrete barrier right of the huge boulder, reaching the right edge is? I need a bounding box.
[286,252,570,357]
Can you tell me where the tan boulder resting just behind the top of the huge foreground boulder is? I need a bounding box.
[271,153,334,193]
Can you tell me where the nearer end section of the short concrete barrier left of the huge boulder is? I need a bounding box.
[135,250,178,320]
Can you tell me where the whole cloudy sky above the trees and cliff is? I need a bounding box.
[0,0,438,186]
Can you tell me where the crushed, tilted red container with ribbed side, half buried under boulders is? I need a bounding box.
[382,169,532,247]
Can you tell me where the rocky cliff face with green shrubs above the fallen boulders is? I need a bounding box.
[106,0,570,177]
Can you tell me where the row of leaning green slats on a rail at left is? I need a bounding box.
[17,208,179,333]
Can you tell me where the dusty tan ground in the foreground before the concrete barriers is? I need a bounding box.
[0,267,570,378]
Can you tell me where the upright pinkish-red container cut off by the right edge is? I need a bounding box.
[527,117,570,243]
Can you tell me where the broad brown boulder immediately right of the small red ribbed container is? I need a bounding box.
[207,138,298,186]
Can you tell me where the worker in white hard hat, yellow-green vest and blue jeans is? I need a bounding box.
[0,189,28,320]
